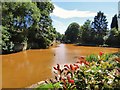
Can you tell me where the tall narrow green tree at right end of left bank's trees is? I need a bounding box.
[28,1,56,48]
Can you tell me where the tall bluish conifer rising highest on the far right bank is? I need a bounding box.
[92,11,108,44]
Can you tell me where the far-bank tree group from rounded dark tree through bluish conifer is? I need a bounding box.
[65,11,112,45]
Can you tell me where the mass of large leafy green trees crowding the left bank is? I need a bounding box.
[2,0,56,52]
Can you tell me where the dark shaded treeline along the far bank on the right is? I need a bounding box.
[64,11,120,47]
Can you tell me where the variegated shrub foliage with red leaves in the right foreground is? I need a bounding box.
[37,52,120,90]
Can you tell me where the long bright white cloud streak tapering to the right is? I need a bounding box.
[51,4,96,19]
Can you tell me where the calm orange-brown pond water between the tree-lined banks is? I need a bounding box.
[1,44,118,88]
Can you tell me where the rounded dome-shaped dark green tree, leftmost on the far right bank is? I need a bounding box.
[65,22,80,43]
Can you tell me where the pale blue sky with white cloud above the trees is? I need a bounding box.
[51,0,118,34]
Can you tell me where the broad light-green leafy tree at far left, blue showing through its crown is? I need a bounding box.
[2,2,41,50]
